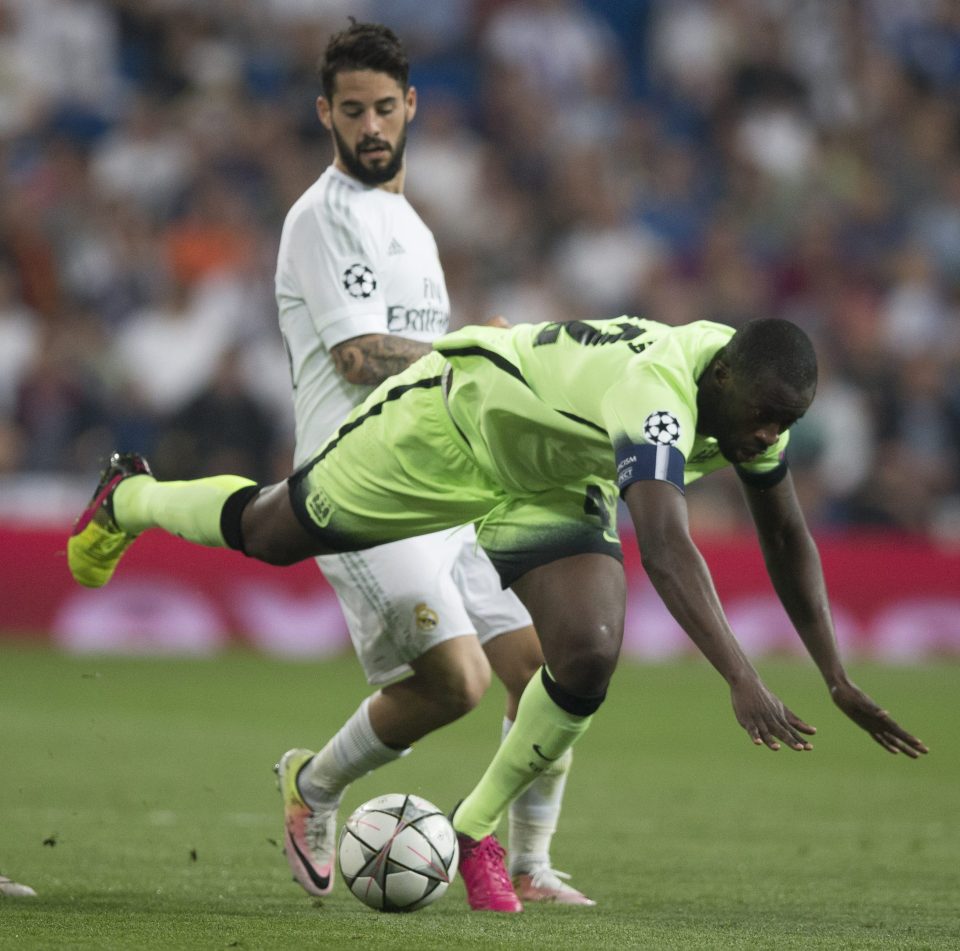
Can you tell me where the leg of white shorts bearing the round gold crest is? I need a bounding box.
[317,532,479,684]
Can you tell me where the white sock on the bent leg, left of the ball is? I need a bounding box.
[297,696,410,811]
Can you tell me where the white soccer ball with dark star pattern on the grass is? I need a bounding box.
[337,793,460,911]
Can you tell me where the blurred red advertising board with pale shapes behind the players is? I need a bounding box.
[0,525,960,661]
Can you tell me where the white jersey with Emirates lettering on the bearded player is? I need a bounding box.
[276,166,450,465]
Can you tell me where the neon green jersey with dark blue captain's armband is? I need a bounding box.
[434,316,789,494]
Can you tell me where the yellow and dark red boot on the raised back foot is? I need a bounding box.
[67,452,153,588]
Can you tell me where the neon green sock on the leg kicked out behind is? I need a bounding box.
[113,475,255,548]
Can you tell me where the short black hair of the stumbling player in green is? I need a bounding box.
[723,317,817,390]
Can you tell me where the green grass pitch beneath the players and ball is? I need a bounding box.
[0,643,960,951]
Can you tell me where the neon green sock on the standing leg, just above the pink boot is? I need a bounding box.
[453,673,593,839]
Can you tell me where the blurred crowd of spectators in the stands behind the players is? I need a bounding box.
[0,0,960,542]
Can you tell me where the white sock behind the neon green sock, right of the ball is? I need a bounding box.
[501,717,573,875]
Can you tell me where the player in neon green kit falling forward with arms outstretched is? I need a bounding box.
[68,317,927,910]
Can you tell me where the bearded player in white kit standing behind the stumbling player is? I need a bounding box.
[266,22,593,911]
